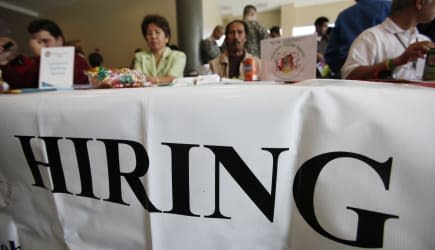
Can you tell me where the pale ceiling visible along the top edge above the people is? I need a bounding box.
[0,0,345,16]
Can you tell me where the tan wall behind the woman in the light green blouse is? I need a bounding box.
[43,0,177,67]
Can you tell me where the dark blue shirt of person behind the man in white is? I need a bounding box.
[325,0,391,75]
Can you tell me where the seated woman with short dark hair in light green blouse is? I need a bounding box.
[134,15,186,84]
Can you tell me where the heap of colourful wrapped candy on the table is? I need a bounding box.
[86,66,150,89]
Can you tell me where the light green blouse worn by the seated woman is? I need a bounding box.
[134,47,186,78]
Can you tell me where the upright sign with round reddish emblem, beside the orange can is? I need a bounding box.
[261,35,317,82]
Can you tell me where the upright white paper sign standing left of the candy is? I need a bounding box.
[39,47,74,88]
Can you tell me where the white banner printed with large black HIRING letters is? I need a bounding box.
[0,80,435,250]
